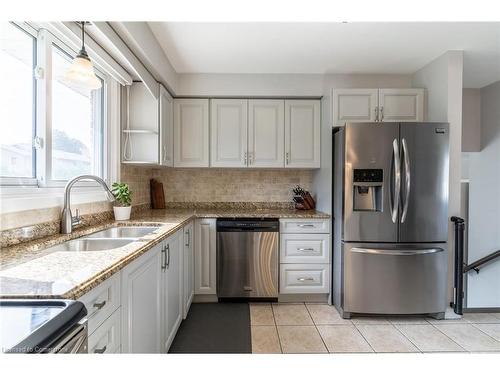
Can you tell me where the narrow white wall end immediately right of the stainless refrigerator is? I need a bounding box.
[412,51,463,301]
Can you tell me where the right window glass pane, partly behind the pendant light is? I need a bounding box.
[52,46,104,180]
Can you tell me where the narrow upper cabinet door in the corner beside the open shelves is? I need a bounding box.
[160,85,174,167]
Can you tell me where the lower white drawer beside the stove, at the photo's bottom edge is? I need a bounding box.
[88,309,121,354]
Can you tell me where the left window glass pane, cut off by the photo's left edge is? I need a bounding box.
[0,22,36,178]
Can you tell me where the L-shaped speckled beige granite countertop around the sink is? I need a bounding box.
[0,208,330,299]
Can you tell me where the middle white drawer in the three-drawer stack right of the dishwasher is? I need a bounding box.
[280,233,330,263]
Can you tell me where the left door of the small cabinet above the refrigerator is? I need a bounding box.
[332,89,378,126]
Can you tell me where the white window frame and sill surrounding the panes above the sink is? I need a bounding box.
[0,22,120,213]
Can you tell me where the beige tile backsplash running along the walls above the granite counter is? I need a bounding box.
[0,165,313,230]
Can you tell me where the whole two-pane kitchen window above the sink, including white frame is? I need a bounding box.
[0,22,109,192]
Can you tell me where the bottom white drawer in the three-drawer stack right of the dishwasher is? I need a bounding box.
[280,264,330,294]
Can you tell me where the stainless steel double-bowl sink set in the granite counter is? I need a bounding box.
[47,226,159,252]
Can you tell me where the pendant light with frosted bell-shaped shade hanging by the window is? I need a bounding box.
[64,21,102,90]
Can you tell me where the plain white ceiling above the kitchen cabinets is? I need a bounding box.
[149,22,500,88]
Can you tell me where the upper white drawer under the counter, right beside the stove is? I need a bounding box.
[80,272,120,334]
